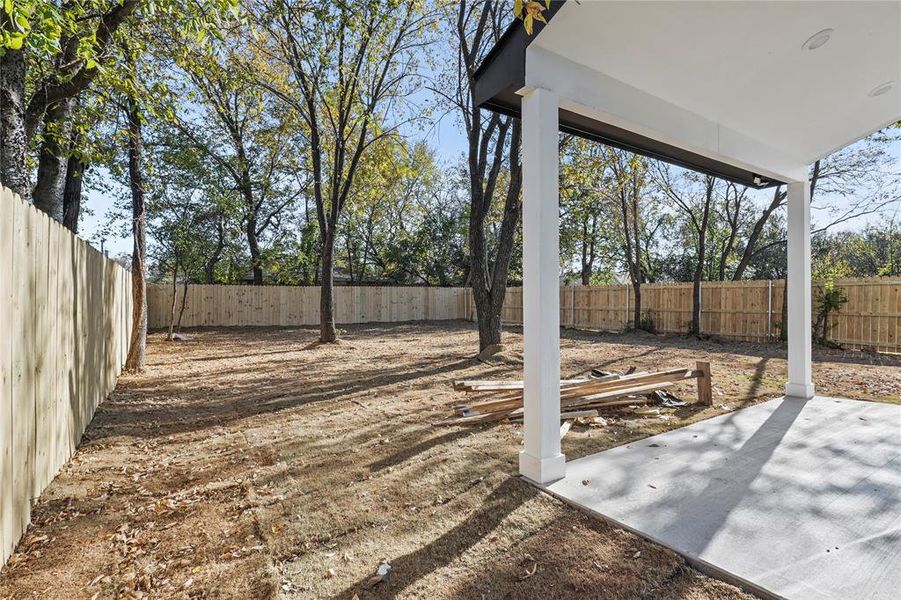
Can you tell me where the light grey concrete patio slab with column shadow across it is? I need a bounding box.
[545,397,901,600]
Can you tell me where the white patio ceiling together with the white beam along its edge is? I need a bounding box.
[525,0,901,180]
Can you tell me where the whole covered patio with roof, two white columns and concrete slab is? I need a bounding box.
[476,1,901,598]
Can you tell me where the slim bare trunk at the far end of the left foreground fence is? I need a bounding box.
[125,98,147,371]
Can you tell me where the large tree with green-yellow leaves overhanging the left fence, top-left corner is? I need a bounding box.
[0,0,235,222]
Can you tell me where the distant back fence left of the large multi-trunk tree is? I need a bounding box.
[147,285,469,329]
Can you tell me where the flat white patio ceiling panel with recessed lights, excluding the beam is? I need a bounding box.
[533,0,901,164]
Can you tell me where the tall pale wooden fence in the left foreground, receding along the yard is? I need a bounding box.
[0,188,131,565]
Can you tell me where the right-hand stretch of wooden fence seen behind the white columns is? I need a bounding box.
[502,277,901,352]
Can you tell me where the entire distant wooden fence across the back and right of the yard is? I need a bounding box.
[148,278,901,352]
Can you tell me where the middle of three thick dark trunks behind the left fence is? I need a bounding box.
[32,98,75,223]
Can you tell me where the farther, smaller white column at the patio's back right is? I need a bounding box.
[785,180,814,399]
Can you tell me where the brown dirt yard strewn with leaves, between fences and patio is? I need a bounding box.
[0,323,901,599]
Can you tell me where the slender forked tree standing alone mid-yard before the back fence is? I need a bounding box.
[253,0,434,343]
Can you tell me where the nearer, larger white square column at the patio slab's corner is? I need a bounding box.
[519,88,566,484]
